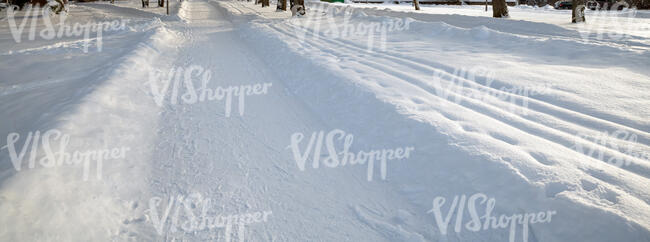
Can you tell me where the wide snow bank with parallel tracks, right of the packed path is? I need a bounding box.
[216,2,650,241]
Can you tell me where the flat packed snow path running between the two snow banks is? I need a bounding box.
[143,1,400,241]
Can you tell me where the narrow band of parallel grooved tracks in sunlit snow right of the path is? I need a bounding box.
[262,22,650,186]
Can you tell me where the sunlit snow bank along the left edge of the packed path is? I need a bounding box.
[0,9,185,241]
